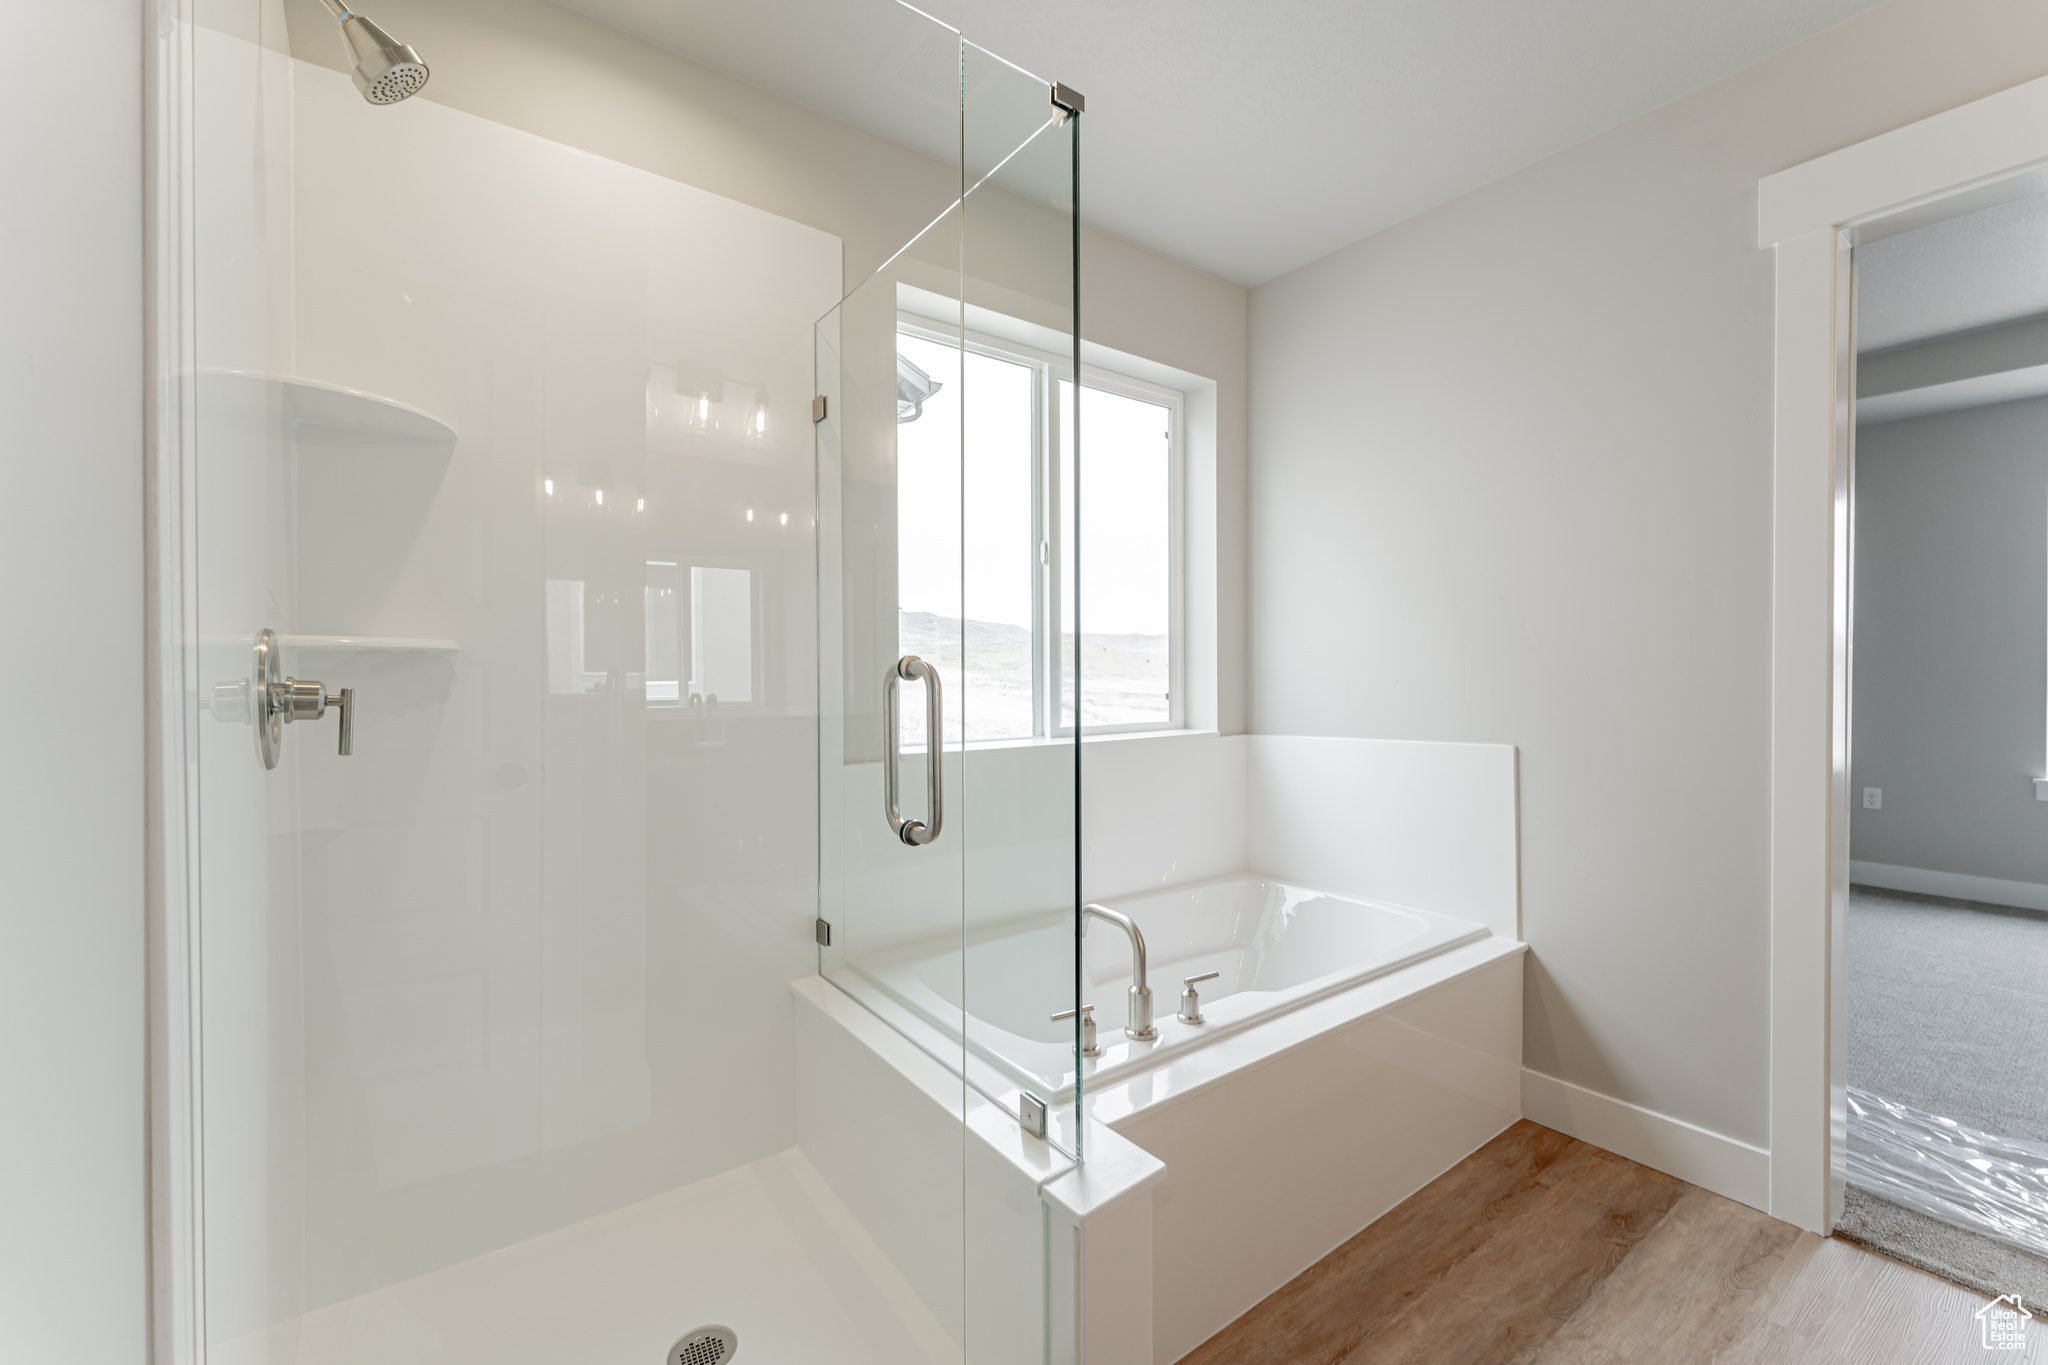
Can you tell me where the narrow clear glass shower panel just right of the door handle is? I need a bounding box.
[961,43,1089,1361]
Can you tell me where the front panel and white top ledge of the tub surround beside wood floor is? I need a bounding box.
[1092,939,1526,1365]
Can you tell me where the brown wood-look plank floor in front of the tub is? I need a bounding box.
[1182,1121,2048,1365]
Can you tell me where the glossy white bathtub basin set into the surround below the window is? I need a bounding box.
[850,876,1489,1105]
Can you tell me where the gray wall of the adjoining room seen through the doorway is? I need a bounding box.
[1849,399,2048,884]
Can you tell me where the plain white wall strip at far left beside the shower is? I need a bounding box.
[0,0,147,1365]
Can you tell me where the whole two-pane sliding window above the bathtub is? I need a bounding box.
[897,317,1182,747]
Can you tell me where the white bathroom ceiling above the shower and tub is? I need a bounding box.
[561,0,1876,284]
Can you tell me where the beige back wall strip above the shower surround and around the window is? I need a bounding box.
[285,0,1247,733]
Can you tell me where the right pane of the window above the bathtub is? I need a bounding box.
[1059,383,1174,729]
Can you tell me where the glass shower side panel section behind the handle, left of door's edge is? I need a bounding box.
[817,207,963,1074]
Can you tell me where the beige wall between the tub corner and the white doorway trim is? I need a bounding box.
[1249,0,2048,1146]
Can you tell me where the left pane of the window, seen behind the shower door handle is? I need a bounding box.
[897,336,1034,749]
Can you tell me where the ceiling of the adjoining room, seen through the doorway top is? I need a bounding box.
[1855,194,2048,352]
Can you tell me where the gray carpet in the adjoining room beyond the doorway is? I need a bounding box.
[1837,886,2048,1302]
